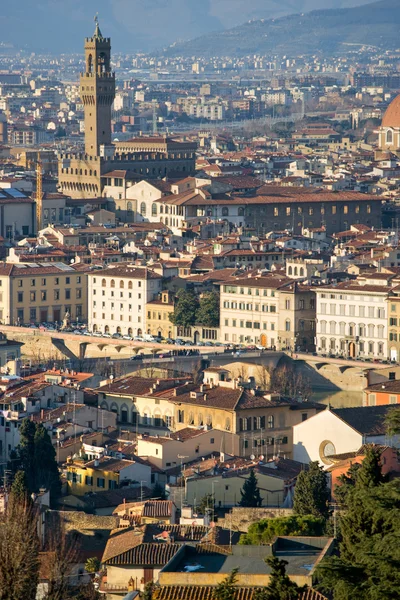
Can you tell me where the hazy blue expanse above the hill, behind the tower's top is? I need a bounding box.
[0,0,366,52]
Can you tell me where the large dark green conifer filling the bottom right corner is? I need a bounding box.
[317,452,400,600]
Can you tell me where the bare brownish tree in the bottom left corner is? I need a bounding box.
[0,493,39,600]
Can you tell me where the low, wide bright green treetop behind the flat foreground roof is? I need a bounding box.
[239,515,325,546]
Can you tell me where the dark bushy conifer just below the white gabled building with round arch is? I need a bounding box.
[293,461,330,518]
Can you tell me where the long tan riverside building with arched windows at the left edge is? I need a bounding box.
[0,262,87,325]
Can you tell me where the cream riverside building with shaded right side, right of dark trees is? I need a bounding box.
[220,273,315,350]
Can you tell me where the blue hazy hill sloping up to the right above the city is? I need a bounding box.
[164,0,400,56]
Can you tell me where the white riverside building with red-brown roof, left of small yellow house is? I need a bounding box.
[88,265,162,337]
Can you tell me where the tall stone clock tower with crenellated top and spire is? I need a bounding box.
[80,17,115,156]
